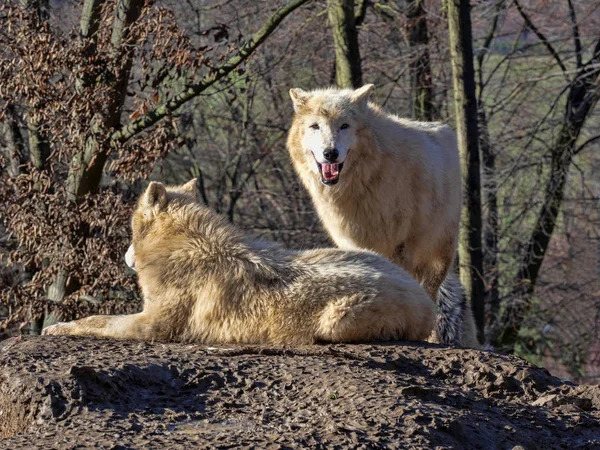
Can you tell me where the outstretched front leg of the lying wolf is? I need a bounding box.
[42,313,154,340]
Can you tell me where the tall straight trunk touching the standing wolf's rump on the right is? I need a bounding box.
[446,0,485,342]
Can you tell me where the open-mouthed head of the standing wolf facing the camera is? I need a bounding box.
[290,84,373,185]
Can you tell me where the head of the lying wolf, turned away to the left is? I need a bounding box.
[125,178,197,270]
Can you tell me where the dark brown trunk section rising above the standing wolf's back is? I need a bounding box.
[406,0,435,121]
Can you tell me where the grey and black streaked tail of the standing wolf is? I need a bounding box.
[436,273,480,348]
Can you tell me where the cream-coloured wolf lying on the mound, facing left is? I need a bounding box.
[44,180,435,345]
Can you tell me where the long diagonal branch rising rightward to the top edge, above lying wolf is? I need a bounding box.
[111,0,308,143]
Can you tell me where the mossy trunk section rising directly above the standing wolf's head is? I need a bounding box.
[327,0,362,89]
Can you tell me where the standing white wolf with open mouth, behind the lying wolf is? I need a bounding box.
[287,84,476,346]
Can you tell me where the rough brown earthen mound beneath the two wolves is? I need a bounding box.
[0,336,600,450]
